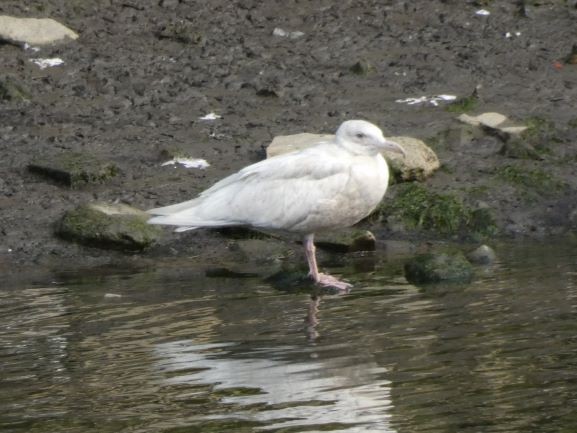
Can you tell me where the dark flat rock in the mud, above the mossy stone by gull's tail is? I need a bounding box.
[28,152,120,188]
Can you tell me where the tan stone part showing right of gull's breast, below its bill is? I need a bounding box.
[383,137,441,182]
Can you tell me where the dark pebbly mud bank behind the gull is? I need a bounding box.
[0,0,577,270]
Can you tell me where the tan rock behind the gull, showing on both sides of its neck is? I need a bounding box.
[266,132,440,181]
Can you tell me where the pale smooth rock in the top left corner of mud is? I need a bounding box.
[0,15,78,46]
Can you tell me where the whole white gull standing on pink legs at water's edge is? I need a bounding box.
[148,120,404,289]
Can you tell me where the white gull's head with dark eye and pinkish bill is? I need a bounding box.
[335,120,406,156]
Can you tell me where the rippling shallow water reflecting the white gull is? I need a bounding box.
[0,243,577,433]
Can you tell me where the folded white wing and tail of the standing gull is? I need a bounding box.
[149,143,350,231]
